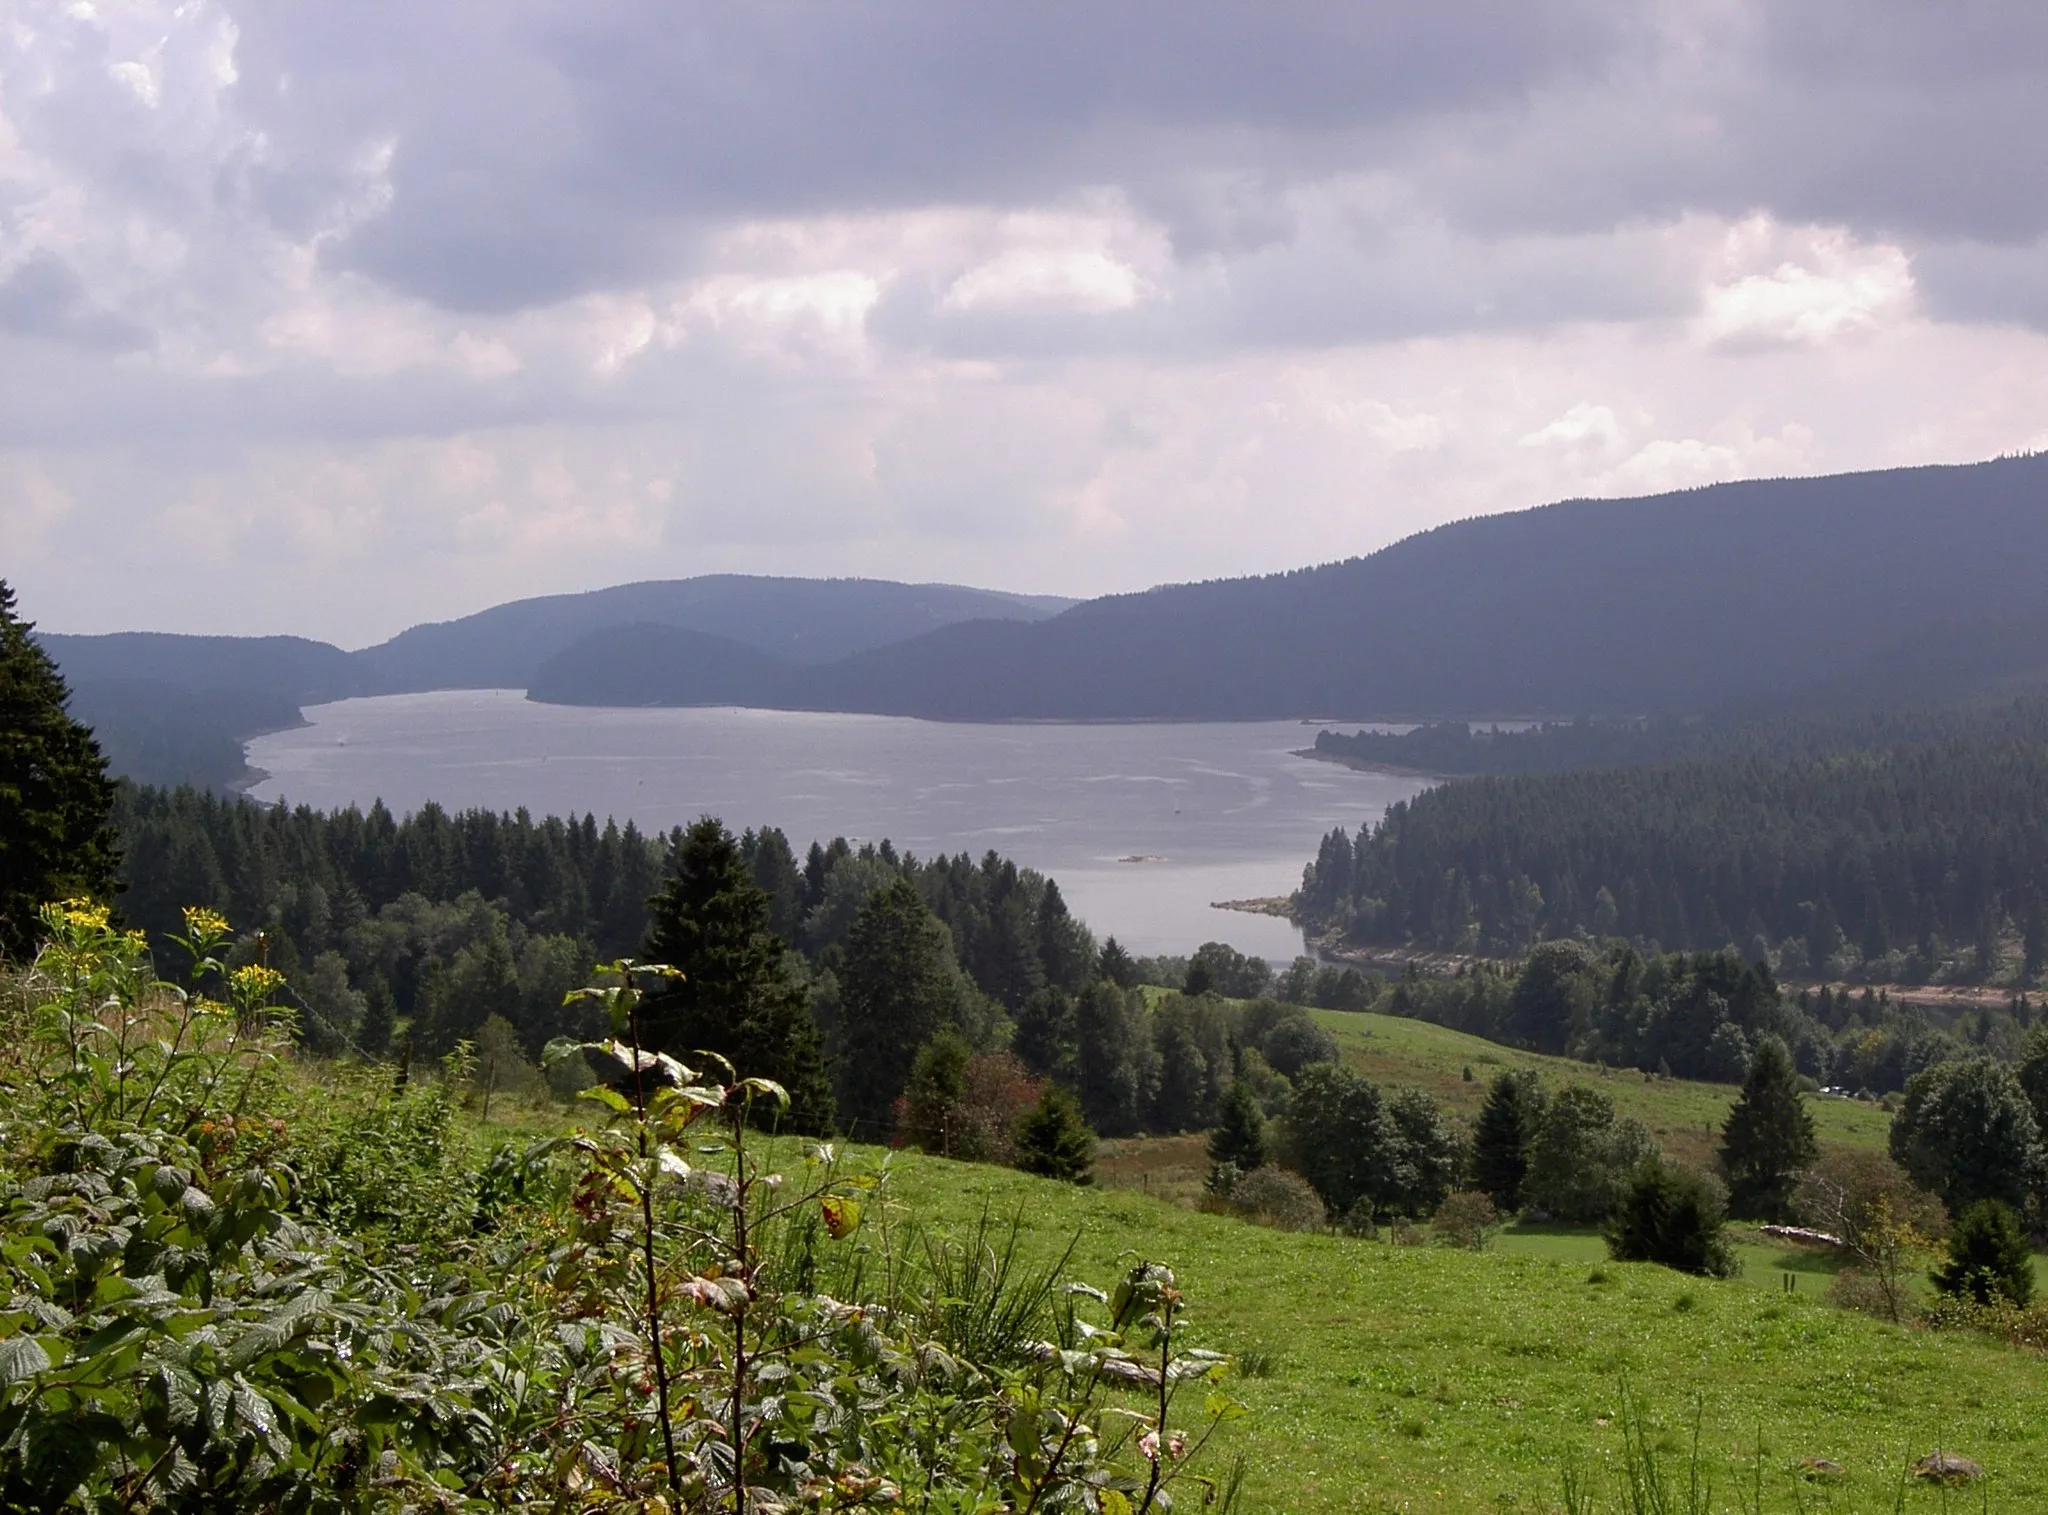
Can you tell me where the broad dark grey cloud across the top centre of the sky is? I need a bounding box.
[220,0,1614,309]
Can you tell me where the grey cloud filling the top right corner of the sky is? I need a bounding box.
[1413,0,2048,251]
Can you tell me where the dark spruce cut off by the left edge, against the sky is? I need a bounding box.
[0,579,115,958]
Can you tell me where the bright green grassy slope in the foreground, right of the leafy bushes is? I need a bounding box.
[860,1157,2048,1513]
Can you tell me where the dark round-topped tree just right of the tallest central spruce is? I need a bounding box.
[838,878,961,1140]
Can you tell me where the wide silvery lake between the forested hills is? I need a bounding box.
[250,690,1425,962]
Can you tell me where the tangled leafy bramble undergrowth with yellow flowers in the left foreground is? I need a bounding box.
[0,903,1239,1515]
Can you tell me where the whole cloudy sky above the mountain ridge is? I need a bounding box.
[0,0,2048,645]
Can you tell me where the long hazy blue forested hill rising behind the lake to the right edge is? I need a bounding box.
[811,457,2048,719]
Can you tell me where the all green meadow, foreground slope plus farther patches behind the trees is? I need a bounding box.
[444,994,1998,1515]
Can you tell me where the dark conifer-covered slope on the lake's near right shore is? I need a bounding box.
[1296,704,2048,987]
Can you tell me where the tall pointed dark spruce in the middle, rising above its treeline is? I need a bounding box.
[641,815,834,1134]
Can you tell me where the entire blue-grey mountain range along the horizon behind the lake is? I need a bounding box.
[45,455,2048,794]
